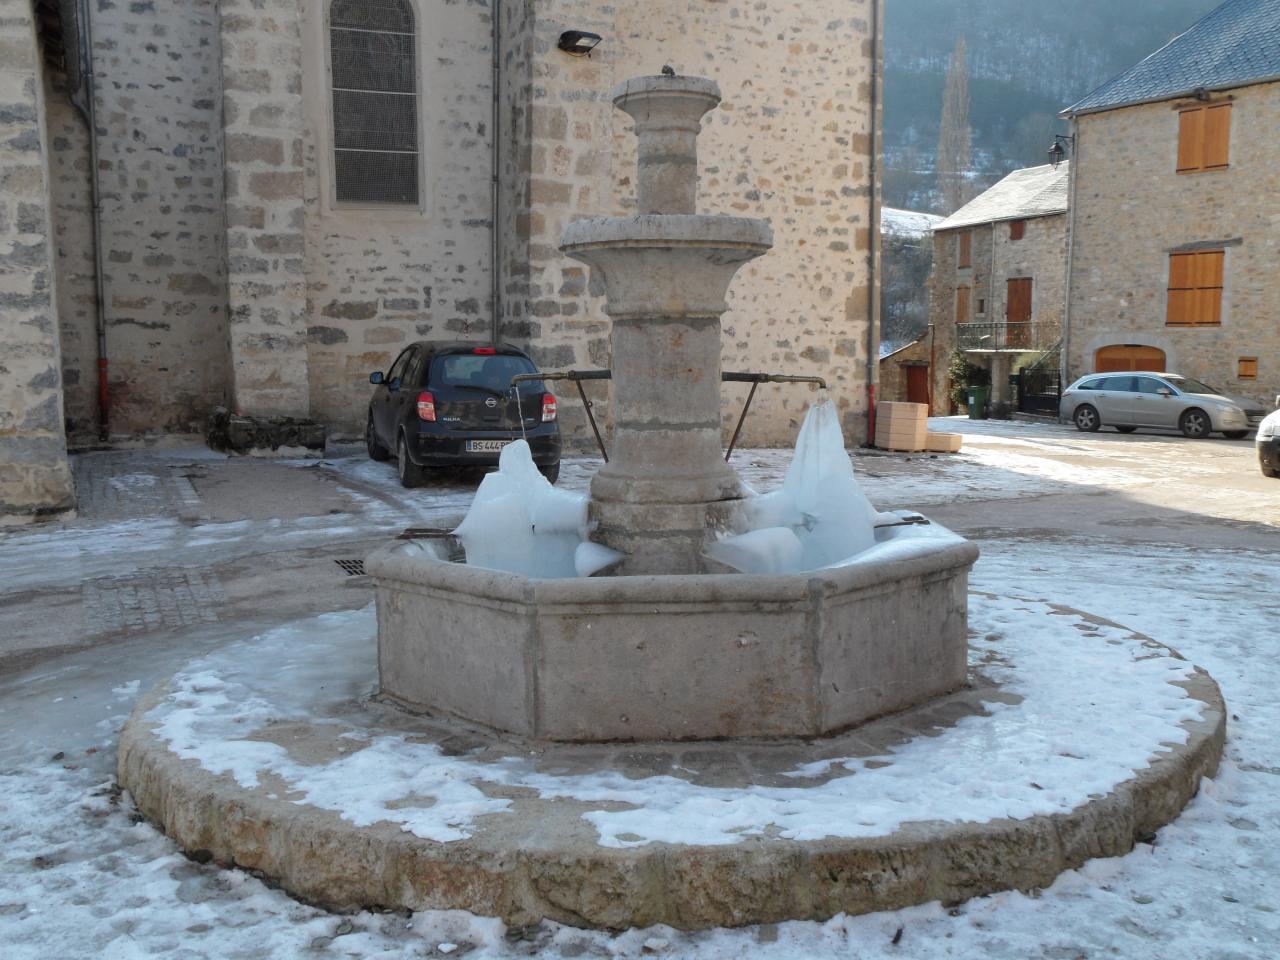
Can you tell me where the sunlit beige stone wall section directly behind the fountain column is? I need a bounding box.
[504,0,878,444]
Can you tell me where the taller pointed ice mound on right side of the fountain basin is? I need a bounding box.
[707,393,897,573]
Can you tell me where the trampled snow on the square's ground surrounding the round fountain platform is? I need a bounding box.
[0,437,1280,960]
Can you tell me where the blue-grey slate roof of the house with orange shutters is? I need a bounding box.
[1062,0,1280,116]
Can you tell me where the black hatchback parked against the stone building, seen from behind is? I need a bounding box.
[365,340,561,486]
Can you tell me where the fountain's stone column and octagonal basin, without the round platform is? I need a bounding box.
[366,76,978,741]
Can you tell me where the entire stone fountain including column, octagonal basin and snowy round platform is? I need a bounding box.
[119,76,1225,929]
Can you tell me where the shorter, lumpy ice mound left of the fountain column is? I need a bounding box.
[453,440,622,577]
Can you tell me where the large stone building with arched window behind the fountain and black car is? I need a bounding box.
[0,0,881,513]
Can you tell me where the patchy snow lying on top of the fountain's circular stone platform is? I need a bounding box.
[147,596,1199,847]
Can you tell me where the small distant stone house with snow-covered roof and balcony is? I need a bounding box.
[929,163,1070,413]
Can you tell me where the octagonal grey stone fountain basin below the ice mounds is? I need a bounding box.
[365,515,978,741]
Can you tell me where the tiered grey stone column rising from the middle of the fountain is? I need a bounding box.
[561,76,773,575]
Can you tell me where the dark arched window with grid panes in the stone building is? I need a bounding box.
[329,0,419,206]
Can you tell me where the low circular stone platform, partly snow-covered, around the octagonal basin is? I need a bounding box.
[119,595,1225,929]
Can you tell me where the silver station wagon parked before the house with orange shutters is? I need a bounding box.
[1059,371,1266,440]
